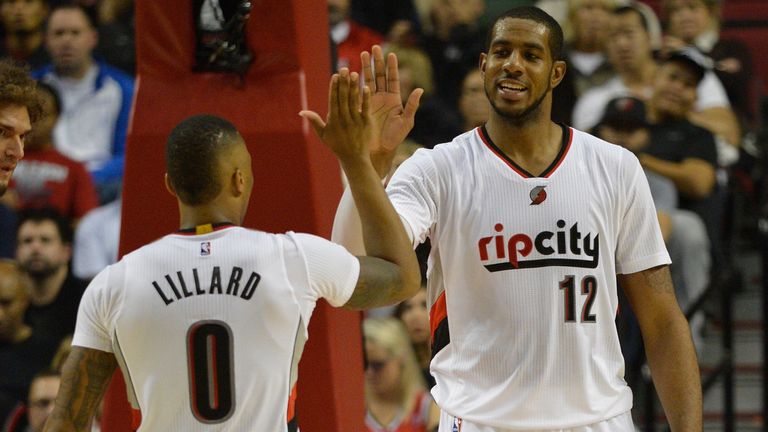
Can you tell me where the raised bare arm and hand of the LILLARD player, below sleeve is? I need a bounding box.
[302,69,421,309]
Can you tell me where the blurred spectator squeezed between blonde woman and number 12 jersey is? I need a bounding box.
[394,285,435,389]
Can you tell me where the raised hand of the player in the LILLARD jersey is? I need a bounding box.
[299,68,377,164]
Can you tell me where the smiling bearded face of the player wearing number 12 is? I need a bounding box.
[480,18,565,123]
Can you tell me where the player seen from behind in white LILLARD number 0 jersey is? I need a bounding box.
[45,111,420,431]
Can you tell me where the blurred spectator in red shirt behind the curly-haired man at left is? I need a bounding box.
[11,82,98,221]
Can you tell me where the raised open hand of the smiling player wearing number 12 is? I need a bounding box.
[360,45,424,177]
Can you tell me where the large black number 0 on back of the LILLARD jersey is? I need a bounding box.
[187,320,235,423]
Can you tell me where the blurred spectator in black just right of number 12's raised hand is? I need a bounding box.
[387,45,461,148]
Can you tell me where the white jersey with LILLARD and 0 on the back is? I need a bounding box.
[73,226,359,431]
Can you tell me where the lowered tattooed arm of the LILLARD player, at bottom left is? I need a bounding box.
[43,346,117,432]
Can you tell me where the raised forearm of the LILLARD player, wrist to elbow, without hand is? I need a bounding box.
[342,160,421,298]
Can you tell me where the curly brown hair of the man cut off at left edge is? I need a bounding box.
[0,60,43,123]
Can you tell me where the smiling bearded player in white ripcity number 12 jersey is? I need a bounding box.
[306,7,702,432]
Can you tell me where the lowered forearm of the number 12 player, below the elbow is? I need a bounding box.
[644,314,702,432]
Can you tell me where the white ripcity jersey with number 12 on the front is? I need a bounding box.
[388,127,670,430]
